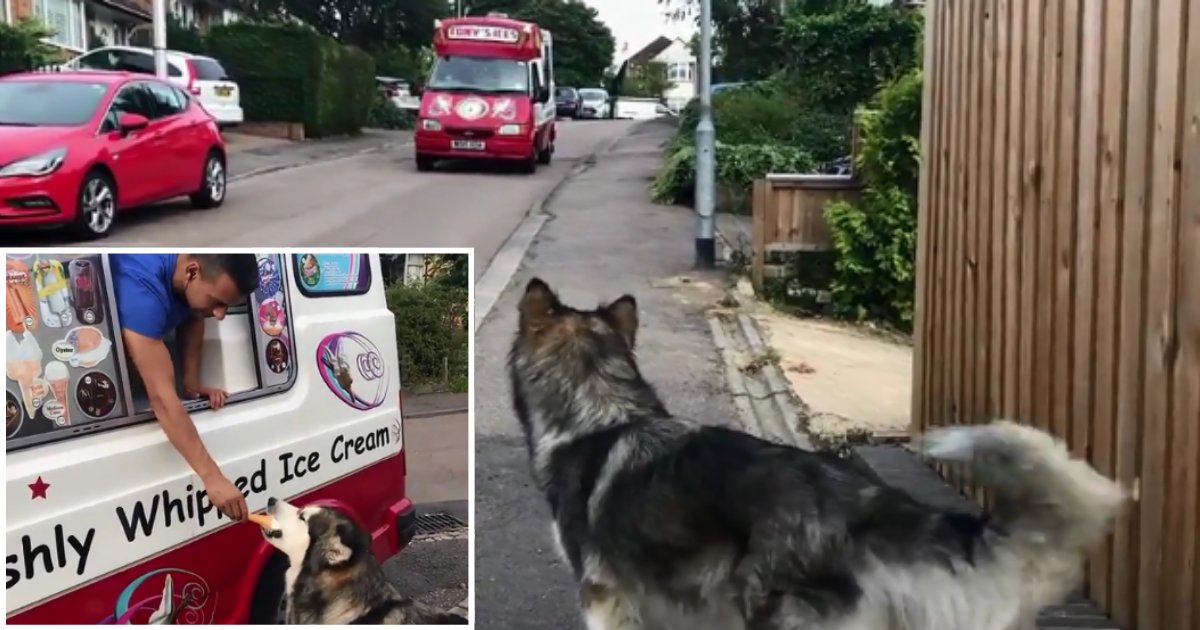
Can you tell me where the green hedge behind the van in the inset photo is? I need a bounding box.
[386,283,469,391]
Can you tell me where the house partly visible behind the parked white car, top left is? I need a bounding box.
[0,0,240,56]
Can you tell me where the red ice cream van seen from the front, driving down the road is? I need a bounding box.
[413,13,557,173]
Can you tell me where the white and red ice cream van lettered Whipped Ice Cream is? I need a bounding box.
[5,252,415,624]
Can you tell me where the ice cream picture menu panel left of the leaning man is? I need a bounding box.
[5,254,126,448]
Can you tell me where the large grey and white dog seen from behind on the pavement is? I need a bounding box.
[509,278,1129,630]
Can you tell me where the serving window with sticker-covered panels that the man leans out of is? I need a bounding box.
[5,253,295,451]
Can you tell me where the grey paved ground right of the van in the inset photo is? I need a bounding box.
[384,397,472,612]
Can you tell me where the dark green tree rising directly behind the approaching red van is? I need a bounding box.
[451,0,617,86]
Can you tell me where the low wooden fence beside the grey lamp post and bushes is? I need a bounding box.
[750,174,862,292]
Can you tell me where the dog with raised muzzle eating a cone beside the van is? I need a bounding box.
[263,498,467,625]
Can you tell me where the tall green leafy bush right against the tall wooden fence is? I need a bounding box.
[826,70,922,330]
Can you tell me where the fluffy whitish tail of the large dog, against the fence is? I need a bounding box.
[919,420,1136,548]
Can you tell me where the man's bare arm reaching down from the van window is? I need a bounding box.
[121,320,221,480]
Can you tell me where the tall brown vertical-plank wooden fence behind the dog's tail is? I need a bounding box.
[913,0,1200,630]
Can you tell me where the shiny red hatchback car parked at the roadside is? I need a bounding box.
[0,71,226,239]
